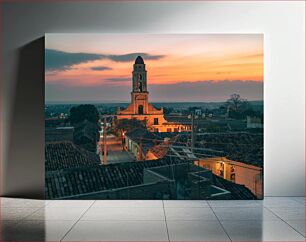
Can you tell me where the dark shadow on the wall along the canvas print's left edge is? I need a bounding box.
[3,37,45,199]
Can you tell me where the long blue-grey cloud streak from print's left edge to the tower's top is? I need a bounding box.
[45,49,164,71]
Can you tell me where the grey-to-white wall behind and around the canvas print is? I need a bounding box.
[1,1,305,196]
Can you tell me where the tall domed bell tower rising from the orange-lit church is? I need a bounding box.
[131,56,149,115]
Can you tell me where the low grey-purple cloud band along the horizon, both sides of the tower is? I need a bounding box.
[46,77,263,102]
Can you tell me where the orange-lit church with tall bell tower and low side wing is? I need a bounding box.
[116,56,191,132]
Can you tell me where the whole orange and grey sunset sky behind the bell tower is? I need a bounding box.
[45,34,264,102]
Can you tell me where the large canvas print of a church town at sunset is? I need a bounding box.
[45,34,264,200]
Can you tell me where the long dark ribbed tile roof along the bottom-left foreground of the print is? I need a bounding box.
[45,159,184,199]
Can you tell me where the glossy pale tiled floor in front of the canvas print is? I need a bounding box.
[0,197,305,242]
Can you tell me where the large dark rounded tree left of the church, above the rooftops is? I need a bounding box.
[69,104,99,125]
